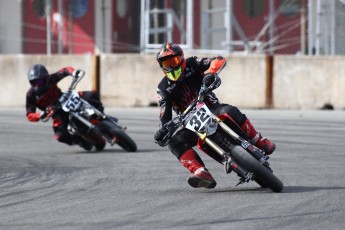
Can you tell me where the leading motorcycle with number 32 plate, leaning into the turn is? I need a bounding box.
[156,83,284,192]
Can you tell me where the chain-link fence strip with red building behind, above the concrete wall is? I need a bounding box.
[0,0,345,55]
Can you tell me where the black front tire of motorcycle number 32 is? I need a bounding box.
[231,146,284,192]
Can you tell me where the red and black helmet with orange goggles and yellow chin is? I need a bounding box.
[156,43,186,81]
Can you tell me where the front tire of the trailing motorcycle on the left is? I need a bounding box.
[99,120,137,152]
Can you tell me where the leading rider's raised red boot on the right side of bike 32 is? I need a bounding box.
[241,118,276,155]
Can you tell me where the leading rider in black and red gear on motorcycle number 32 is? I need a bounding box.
[154,43,276,188]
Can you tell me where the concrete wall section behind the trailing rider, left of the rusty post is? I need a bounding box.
[0,55,94,106]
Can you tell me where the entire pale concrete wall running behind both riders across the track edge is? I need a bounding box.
[0,54,345,109]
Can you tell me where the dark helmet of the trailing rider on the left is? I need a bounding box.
[28,64,49,94]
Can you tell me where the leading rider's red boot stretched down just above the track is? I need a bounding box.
[180,149,217,188]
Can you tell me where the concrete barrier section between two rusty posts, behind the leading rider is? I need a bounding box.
[101,54,266,108]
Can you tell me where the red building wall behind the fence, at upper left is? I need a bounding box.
[22,0,95,54]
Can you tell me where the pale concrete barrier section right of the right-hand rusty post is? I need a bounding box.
[273,56,345,109]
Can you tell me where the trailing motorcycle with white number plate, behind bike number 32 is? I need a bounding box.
[41,70,137,152]
